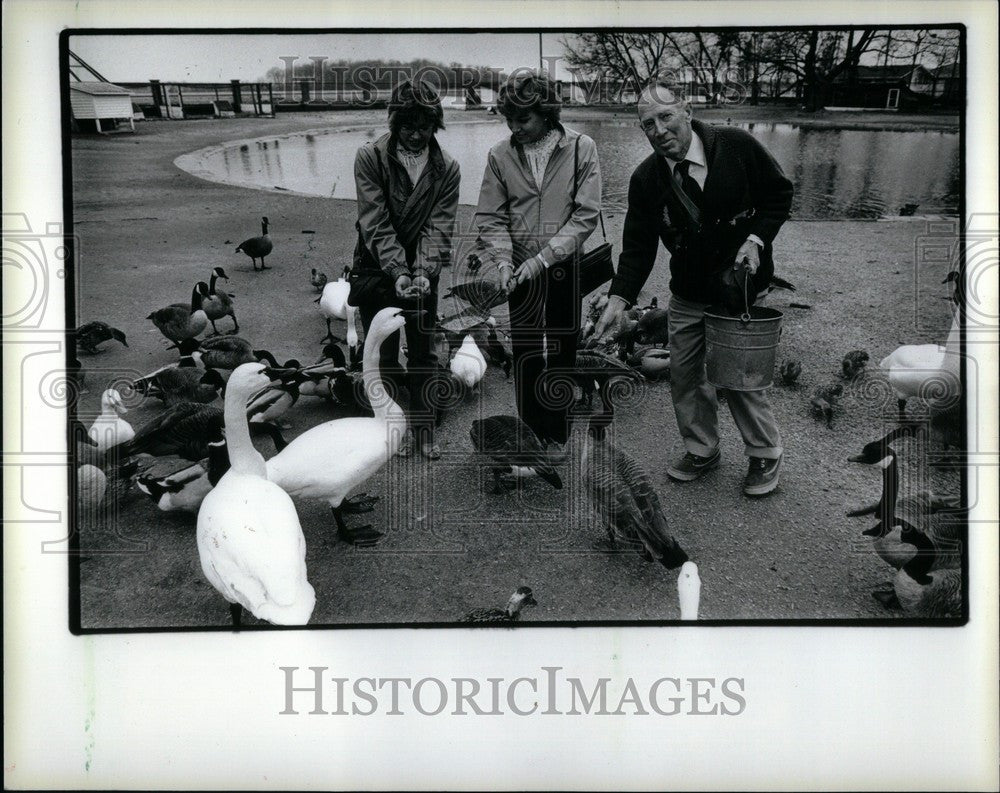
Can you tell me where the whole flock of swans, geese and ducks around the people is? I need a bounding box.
[68,217,962,627]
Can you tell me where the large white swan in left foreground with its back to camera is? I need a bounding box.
[196,363,316,628]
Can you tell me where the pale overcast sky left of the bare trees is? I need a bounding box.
[69,33,565,82]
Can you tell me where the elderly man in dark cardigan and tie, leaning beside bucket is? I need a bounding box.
[595,83,792,496]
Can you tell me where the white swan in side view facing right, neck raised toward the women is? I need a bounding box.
[266,306,414,547]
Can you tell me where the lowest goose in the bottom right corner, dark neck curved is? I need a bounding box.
[892,527,962,618]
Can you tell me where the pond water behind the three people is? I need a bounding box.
[176,119,960,220]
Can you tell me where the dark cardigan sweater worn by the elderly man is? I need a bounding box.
[609,120,792,303]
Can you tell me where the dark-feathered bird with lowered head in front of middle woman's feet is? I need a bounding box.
[469,416,562,494]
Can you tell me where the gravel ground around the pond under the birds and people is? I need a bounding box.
[72,113,958,629]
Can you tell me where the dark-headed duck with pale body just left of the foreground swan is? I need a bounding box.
[135,430,229,514]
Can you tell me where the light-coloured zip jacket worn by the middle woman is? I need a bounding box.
[476,127,601,266]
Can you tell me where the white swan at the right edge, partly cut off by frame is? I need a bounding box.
[879,311,962,421]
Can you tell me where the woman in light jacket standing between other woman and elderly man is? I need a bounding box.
[476,71,601,462]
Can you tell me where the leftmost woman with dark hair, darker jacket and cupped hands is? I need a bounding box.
[349,80,459,460]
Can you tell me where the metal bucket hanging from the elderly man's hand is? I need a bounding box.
[705,306,782,391]
